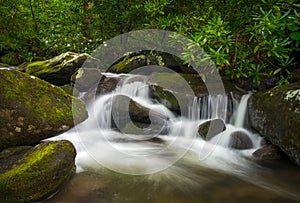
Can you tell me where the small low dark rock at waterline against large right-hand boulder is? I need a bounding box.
[252,145,281,160]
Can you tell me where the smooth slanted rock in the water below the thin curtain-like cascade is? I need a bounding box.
[198,118,226,140]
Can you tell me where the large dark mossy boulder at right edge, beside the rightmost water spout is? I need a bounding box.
[248,83,300,166]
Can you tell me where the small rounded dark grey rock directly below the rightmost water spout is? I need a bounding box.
[228,131,253,149]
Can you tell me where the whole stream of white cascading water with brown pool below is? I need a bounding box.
[45,73,300,203]
